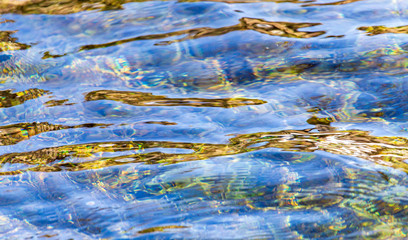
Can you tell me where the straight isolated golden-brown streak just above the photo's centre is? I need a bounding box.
[85,90,266,108]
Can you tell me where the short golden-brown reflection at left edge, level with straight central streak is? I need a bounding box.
[0,88,48,108]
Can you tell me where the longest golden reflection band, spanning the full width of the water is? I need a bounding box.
[0,127,408,174]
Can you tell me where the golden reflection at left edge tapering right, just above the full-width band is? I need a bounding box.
[0,122,108,145]
